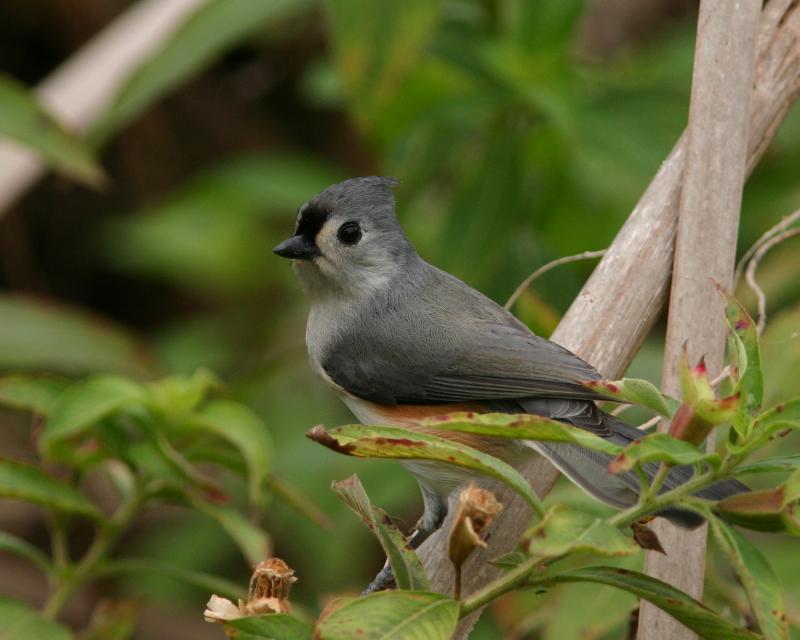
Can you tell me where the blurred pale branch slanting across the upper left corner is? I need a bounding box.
[0,0,208,217]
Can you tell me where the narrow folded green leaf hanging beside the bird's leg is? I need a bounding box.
[333,475,431,591]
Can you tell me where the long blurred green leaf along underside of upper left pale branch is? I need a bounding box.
[91,0,311,140]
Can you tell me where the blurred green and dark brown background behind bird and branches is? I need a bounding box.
[0,0,800,639]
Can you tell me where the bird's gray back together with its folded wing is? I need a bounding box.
[307,258,599,404]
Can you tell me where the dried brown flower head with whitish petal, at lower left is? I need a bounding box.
[203,558,297,622]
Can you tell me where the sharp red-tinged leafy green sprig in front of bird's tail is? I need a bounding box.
[310,297,800,640]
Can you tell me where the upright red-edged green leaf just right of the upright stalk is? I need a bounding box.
[720,291,764,436]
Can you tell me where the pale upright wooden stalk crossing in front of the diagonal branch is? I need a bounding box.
[637,0,761,640]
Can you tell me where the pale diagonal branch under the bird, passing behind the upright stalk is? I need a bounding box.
[420,0,800,638]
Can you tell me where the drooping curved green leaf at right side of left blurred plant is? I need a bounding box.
[187,400,272,507]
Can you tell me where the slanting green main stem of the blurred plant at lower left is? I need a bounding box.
[42,487,144,620]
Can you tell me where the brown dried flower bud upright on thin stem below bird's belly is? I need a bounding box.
[448,484,503,598]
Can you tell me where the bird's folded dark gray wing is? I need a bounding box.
[322,316,600,404]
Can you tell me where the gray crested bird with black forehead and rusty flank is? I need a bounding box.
[274,176,747,593]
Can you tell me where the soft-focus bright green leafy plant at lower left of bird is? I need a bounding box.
[0,371,296,615]
